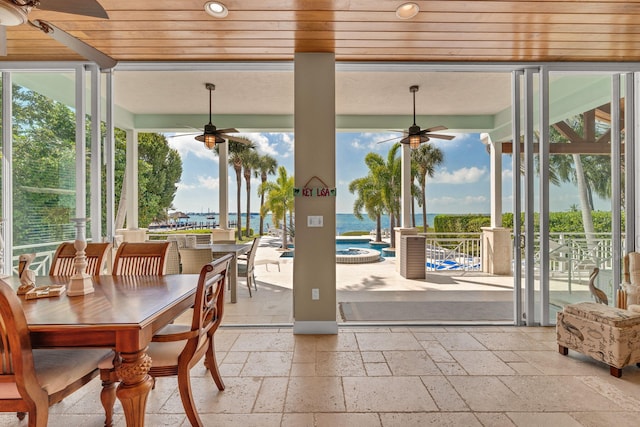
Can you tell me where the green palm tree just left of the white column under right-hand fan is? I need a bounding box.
[364,142,402,248]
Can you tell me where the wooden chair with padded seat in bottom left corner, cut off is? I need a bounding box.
[0,281,111,427]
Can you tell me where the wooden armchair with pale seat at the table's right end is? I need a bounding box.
[100,254,233,426]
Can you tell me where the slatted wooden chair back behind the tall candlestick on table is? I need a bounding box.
[49,242,111,276]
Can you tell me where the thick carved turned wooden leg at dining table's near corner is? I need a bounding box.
[116,350,153,427]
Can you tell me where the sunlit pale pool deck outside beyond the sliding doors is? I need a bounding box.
[223,236,590,325]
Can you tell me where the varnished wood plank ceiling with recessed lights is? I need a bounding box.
[0,0,640,62]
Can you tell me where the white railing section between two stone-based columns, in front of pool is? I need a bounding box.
[421,233,482,271]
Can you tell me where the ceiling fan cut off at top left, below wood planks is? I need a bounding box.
[0,0,116,69]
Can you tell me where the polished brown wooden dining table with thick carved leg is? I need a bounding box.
[0,274,198,427]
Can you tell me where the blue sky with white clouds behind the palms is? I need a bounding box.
[169,132,609,213]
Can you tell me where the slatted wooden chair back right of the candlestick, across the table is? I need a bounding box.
[113,241,169,276]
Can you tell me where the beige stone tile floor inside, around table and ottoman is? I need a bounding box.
[0,326,640,427]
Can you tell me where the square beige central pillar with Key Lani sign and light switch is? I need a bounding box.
[293,53,338,334]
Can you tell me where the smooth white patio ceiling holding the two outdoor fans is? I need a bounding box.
[115,69,511,116]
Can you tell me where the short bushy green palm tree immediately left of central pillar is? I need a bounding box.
[259,166,295,249]
